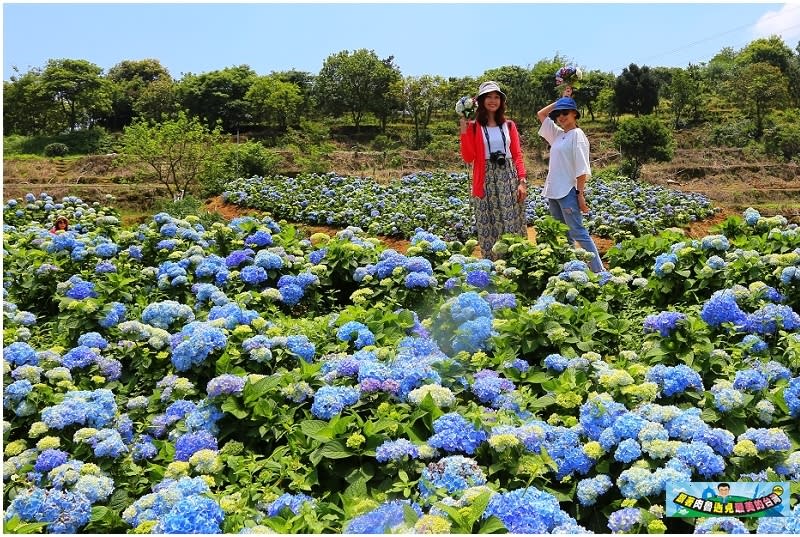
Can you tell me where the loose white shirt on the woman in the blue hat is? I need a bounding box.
[539,117,592,199]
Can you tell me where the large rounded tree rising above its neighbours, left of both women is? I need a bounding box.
[314,49,399,129]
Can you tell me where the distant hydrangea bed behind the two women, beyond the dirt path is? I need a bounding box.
[223,172,714,241]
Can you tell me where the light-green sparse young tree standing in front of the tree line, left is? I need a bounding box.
[119,112,223,199]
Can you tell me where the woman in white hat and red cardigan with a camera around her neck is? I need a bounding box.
[461,80,528,260]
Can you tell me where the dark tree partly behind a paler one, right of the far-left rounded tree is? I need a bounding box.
[106,58,172,130]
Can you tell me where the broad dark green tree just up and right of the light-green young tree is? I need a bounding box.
[178,65,257,132]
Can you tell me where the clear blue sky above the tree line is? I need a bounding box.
[3,3,800,80]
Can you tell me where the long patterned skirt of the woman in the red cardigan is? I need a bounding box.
[472,160,528,260]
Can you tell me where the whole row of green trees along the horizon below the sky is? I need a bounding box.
[3,36,800,154]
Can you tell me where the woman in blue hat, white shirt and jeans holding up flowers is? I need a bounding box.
[536,85,604,272]
